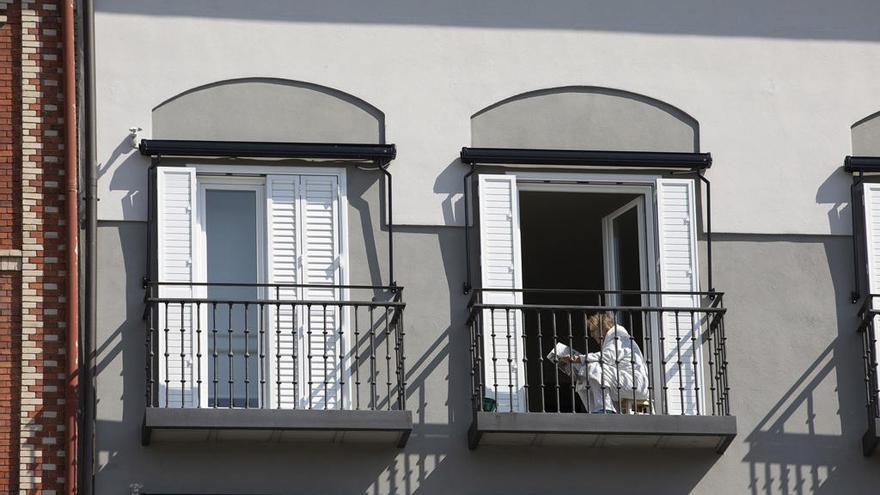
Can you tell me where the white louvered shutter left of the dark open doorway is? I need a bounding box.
[479,175,526,412]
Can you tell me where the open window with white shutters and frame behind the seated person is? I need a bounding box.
[478,174,707,415]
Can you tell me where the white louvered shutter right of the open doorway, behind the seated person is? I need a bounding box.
[655,179,705,414]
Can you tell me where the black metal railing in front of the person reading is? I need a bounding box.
[467,289,730,416]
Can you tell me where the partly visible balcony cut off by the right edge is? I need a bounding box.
[859,294,880,456]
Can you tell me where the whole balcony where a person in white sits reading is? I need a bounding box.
[468,289,736,453]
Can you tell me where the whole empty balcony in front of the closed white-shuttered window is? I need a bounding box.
[142,282,412,446]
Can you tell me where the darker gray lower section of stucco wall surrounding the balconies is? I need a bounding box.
[97,212,880,494]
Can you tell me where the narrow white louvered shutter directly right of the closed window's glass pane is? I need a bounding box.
[266,175,300,409]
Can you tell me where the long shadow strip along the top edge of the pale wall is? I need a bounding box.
[97,0,880,41]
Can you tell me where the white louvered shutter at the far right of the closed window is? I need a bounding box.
[299,175,348,409]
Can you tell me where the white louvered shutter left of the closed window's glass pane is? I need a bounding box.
[156,167,199,407]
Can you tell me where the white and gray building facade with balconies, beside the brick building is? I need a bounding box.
[87,0,880,494]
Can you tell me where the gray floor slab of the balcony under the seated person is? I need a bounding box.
[468,412,736,454]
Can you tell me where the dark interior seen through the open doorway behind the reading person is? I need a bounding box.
[520,191,648,412]
